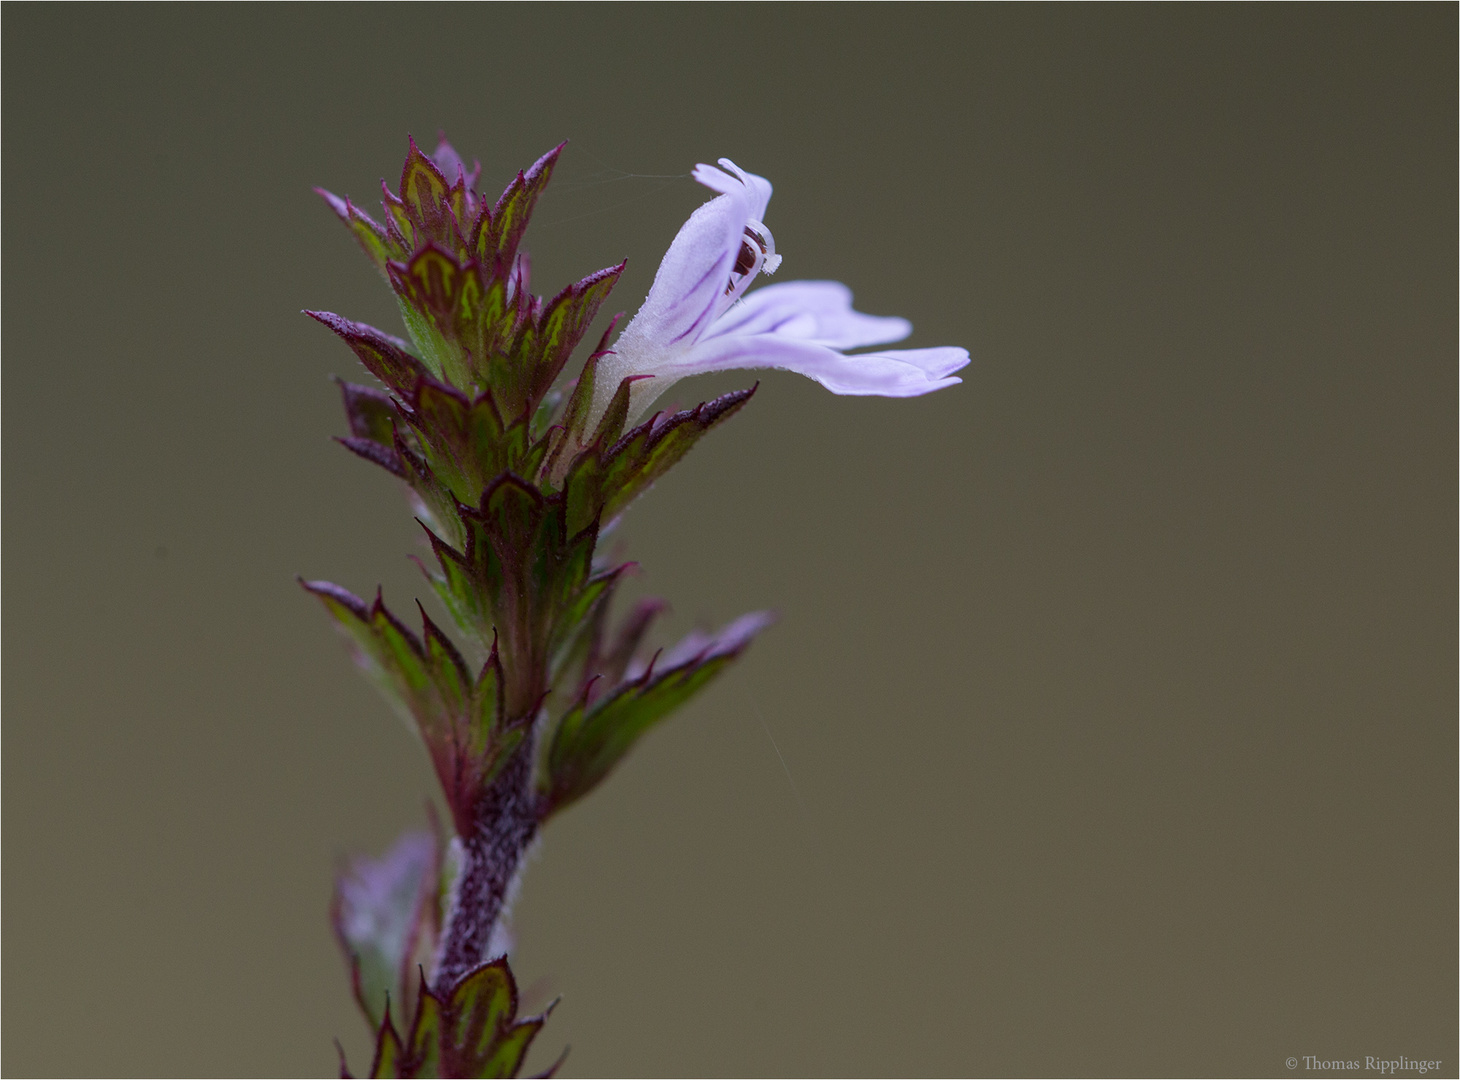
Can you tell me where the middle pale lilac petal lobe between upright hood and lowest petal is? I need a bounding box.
[705,282,913,349]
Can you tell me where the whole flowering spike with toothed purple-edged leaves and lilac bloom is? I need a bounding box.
[310,136,968,1077]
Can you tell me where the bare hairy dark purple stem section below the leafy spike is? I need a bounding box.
[435,740,539,991]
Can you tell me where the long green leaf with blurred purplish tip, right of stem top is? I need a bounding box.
[546,612,772,811]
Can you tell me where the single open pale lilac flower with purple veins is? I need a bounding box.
[588,158,968,431]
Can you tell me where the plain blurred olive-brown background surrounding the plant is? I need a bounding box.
[3,4,1460,1076]
